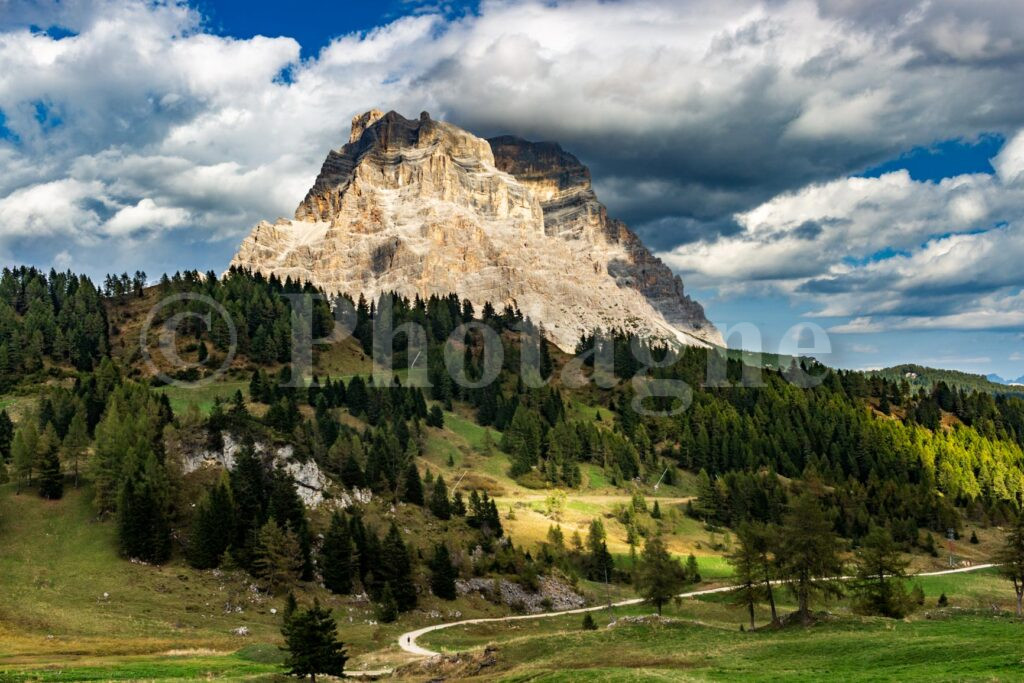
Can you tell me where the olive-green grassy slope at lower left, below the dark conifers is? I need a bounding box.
[0,484,544,680]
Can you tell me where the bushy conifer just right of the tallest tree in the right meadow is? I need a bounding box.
[854,526,909,618]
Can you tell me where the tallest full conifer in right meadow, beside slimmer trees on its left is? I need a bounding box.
[777,494,843,625]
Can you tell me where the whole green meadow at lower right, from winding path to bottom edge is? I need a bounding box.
[422,570,1024,681]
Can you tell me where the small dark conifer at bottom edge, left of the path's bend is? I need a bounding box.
[281,600,348,683]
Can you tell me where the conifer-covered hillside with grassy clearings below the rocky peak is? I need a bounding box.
[0,269,1024,679]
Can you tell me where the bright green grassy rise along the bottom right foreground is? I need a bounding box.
[417,614,1024,681]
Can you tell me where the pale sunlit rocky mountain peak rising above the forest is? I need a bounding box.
[231,110,722,350]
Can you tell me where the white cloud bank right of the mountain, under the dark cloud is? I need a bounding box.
[664,127,1024,334]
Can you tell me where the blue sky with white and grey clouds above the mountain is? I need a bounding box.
[0,0,1024,378]
